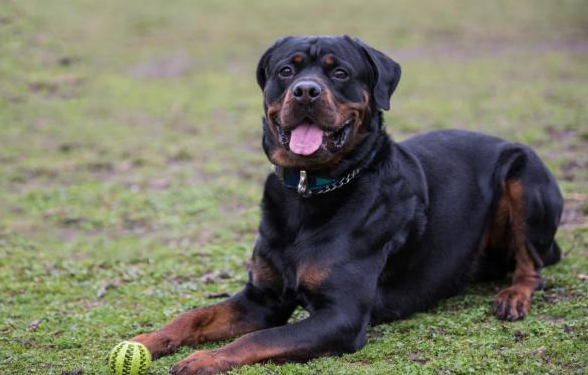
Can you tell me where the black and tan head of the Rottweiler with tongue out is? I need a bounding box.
[257,36,400,170]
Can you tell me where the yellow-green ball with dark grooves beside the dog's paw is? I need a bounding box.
[108,341,151,375]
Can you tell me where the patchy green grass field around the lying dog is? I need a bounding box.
[0,0,588,375]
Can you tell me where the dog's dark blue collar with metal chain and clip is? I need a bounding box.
[274,151,376,198]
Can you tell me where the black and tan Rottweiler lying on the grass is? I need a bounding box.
[132,36,563,375]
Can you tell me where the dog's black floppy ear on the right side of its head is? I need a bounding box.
[352,39,402,111]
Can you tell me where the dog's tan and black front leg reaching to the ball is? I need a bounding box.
[131,284,295,358]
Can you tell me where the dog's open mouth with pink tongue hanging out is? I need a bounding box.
[272,116,355,156]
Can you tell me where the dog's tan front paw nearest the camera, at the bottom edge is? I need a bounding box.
[169,350,236,375]
